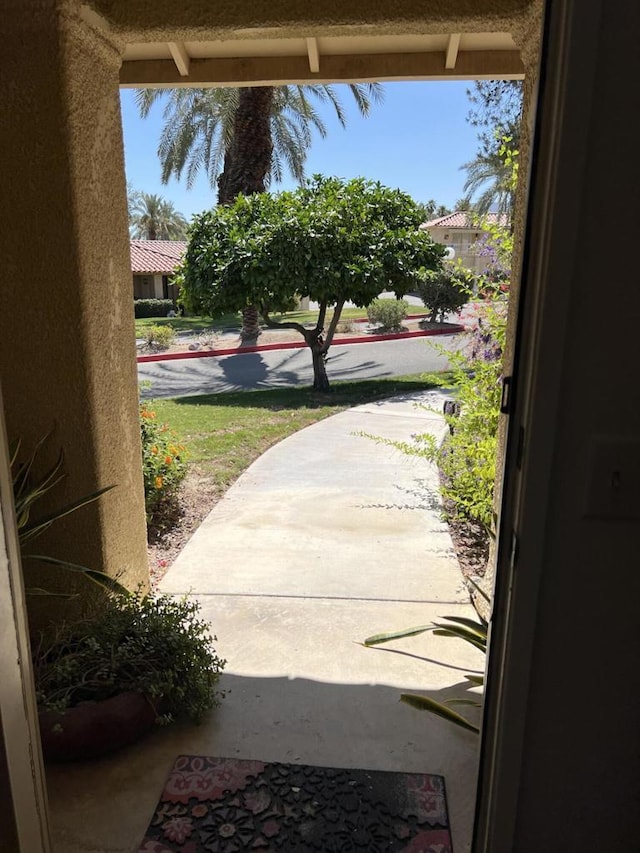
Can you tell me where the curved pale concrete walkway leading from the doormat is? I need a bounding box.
[49,392,484,853]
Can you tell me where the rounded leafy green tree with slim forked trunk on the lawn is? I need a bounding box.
[179,175,444,390]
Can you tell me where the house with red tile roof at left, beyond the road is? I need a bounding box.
[131,240,187,301]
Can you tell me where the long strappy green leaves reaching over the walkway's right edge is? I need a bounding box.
[363,581,489,734]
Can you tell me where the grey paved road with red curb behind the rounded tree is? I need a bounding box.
[138,335,460,397]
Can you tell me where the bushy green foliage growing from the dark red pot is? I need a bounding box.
[34,593,226,723]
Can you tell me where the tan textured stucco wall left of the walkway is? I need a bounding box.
[0,0,147,604]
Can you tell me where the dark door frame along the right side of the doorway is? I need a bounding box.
[472,0,602,853]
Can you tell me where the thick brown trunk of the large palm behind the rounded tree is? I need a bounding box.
[218,86,274,341]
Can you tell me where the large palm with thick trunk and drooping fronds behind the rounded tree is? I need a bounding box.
[136,83,383,340]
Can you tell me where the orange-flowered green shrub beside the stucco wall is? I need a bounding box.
[140,403,187,523]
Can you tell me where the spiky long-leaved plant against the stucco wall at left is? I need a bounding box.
[10,434,127,598]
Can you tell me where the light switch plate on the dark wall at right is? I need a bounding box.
[584,436,640,520]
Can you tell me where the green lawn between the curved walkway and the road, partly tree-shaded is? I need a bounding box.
[147,373,451,506]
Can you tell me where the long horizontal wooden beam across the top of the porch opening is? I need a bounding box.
[120,50,524,88]
